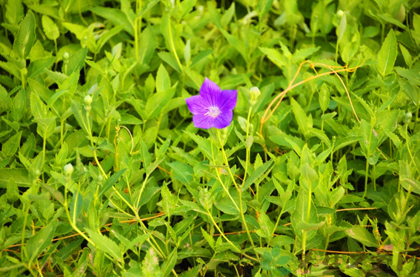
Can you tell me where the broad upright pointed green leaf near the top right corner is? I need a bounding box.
[377,29,398,76]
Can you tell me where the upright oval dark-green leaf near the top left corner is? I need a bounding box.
[13,10,36,59]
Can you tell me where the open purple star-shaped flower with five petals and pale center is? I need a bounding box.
[185,78,238,129]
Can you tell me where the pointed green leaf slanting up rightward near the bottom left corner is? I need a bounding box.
[25,220,58,264]
